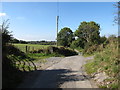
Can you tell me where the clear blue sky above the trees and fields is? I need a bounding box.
[0,2,118,41]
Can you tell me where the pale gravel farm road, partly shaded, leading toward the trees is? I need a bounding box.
[18,55,97,88]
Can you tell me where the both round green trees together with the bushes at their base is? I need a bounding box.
[57,21,116,53]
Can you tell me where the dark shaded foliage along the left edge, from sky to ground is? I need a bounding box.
[0,20,33,89]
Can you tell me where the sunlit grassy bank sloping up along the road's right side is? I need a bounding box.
[85,40,120,88]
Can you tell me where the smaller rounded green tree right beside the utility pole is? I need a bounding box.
[57,27,74,47]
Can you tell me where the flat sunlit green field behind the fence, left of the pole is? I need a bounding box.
[13,44,55,52]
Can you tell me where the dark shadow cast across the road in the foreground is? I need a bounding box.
[19,69,91,88]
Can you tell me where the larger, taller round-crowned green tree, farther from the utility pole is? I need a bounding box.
[75,21,100,46]
